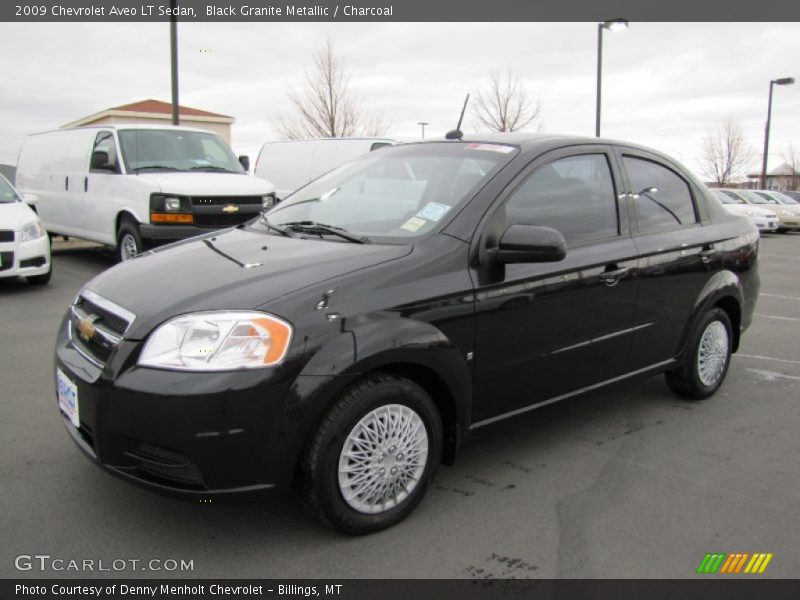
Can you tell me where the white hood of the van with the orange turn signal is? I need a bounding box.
[136,171,275,196]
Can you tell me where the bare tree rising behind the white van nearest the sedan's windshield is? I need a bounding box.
[273,38,389,139]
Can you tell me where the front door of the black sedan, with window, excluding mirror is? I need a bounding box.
[472,145,637,425]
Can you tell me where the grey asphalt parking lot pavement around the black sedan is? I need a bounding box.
[0,234,800,578]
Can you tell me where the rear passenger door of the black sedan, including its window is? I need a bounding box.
[619,148,722,370]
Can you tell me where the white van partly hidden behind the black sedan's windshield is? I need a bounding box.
[253,138,395,200]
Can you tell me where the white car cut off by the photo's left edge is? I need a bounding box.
[0,175,52,285]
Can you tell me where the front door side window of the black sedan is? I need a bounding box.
[506,154,619,245]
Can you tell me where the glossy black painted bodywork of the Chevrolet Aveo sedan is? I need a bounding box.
[56,135,758,497]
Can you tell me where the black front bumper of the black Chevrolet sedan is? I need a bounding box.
[56,319,306,499]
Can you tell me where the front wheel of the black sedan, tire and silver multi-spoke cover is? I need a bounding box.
[300,374,443,535]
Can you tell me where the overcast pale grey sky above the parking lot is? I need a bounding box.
[0,23,800,178]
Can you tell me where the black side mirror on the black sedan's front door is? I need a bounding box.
[489,224,567,264]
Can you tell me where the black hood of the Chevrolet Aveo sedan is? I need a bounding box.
[86,229,412,340]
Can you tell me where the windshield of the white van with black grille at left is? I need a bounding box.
[118,129,244,173]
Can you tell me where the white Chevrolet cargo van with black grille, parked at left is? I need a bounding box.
[16,125,275,260]
